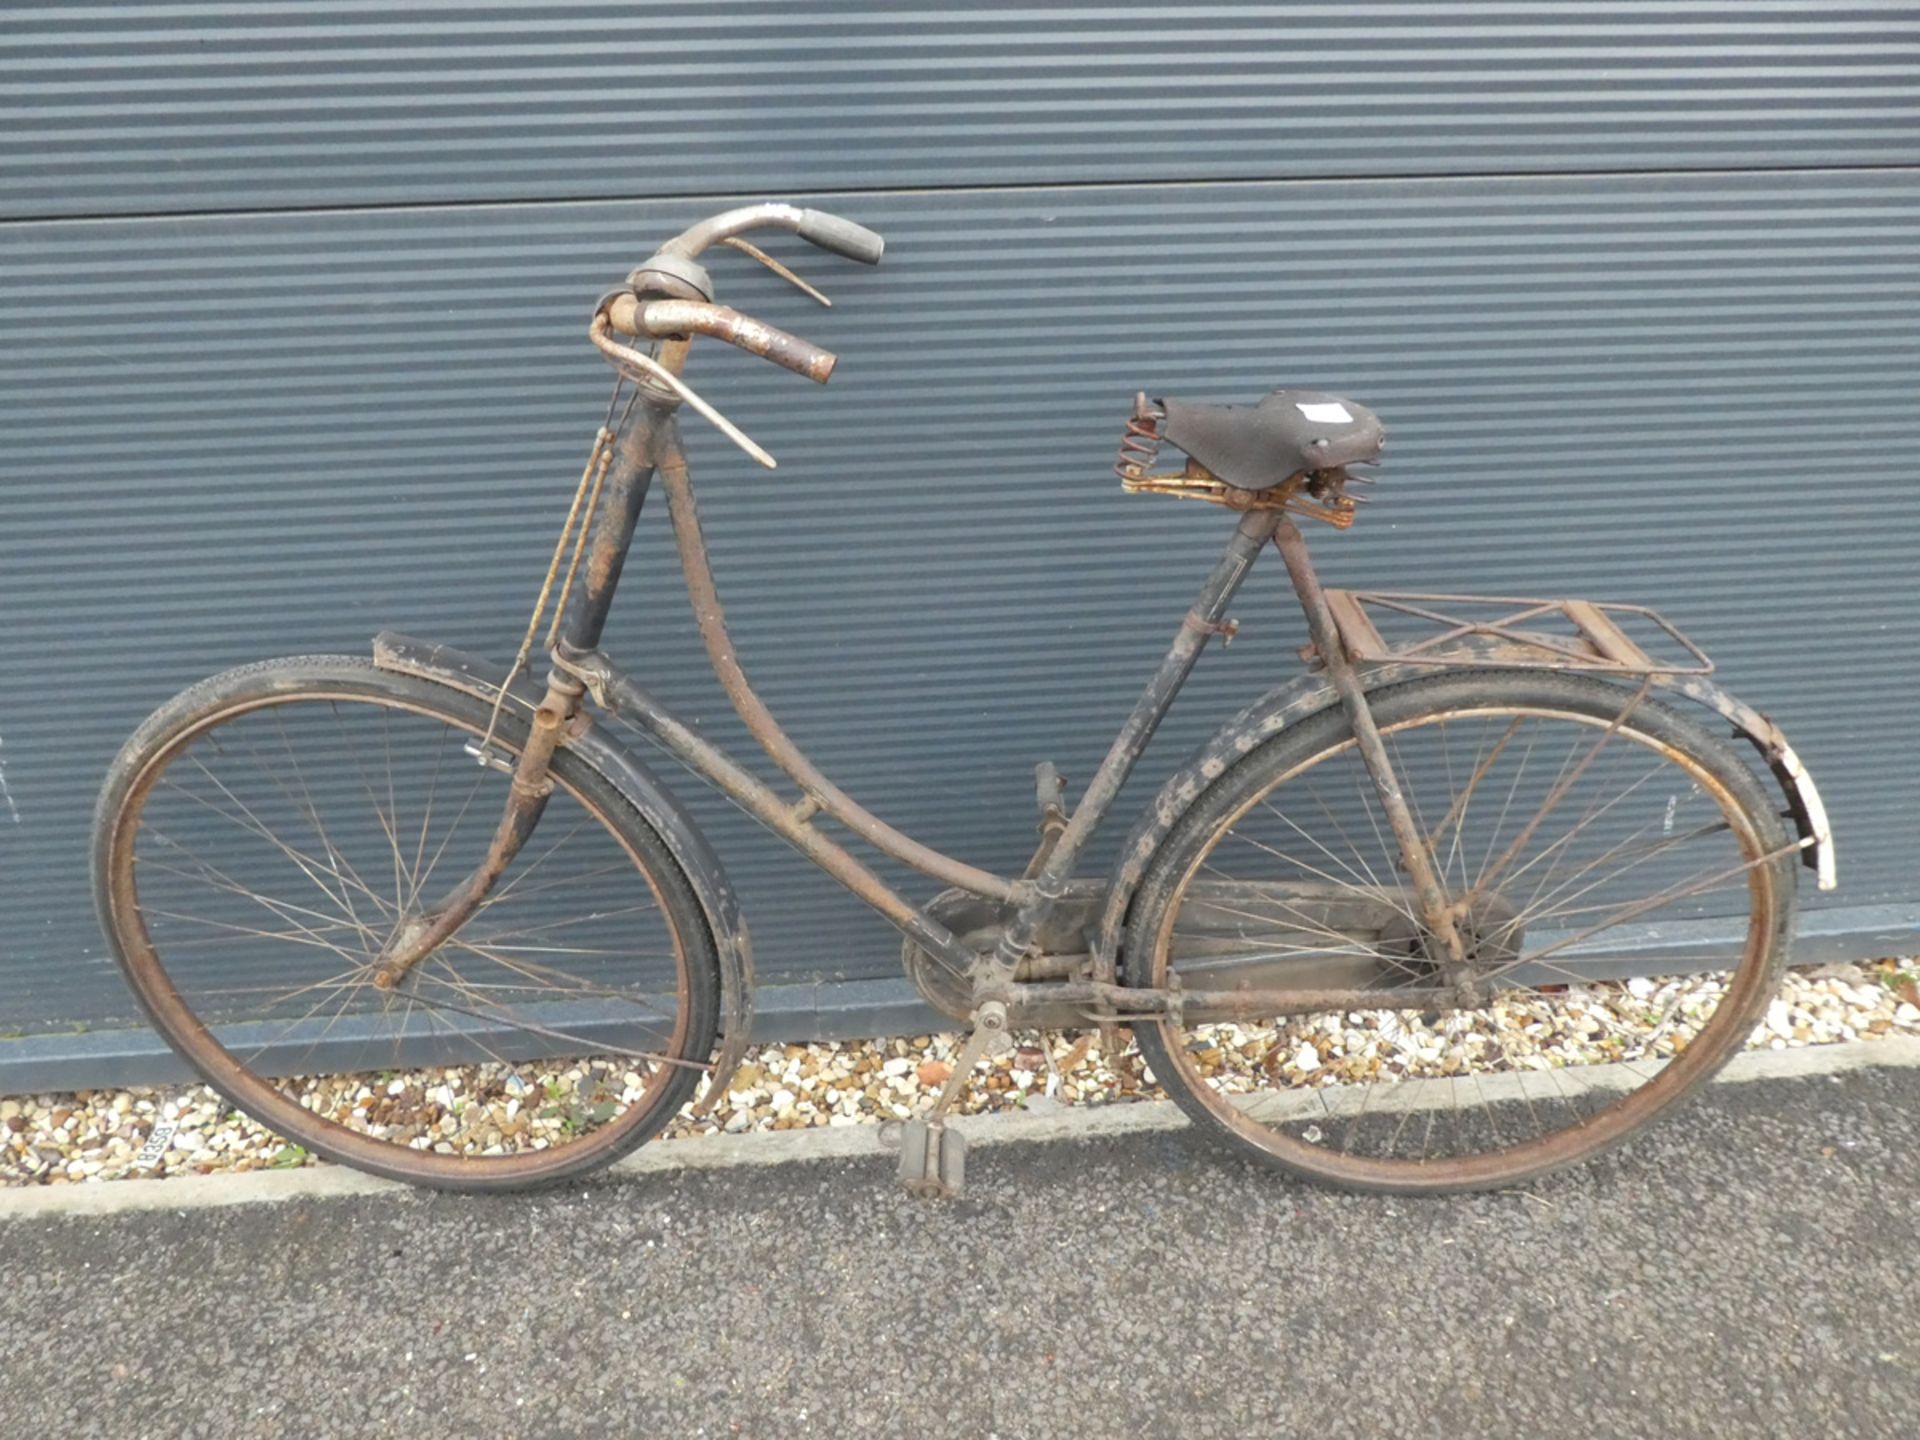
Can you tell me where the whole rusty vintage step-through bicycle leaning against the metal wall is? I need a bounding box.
[94,204,1834,1194]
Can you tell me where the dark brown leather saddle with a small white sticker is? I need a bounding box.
[1154,390,1386,490]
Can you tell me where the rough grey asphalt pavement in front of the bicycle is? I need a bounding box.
[0,1068,1920,1440]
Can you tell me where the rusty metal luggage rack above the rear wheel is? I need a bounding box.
[1327,589,1713,676]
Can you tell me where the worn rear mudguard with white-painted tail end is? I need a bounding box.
[1092,664,1837,975]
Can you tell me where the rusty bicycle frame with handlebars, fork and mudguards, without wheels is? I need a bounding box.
[362,205,1832,1192]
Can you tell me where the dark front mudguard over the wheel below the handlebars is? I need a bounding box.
[372,630,753,1114]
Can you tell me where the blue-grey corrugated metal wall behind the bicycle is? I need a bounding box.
[0,4,1920,1083]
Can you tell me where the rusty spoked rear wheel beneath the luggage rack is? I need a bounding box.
[1125,670,1795,1192]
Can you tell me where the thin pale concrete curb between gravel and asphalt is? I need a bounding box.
[0,1035,1920,1221]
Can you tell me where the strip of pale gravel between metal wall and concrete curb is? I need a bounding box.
[0,960,1920,1185]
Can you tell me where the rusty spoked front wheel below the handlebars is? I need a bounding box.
[94,657,718,1190]
